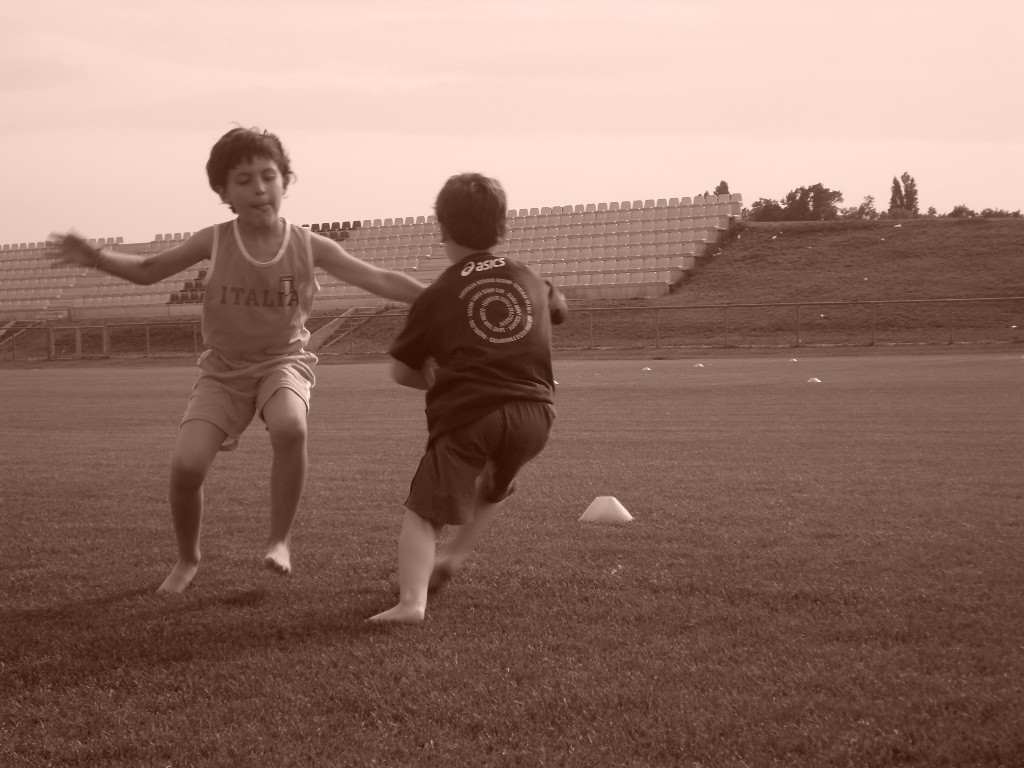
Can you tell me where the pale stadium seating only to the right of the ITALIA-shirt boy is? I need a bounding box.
[312,195,742,306]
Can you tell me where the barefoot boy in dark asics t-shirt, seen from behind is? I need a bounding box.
[370,173,566,623]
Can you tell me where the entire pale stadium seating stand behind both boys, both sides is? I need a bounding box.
[0,195,742,321]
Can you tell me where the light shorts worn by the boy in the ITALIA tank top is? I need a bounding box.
[181,355,316,451]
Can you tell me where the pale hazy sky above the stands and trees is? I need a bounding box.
[0,0,1024,243]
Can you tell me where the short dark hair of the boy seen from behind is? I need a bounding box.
[434,173,507,251]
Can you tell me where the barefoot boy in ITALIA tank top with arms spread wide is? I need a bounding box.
[53,128,425,593]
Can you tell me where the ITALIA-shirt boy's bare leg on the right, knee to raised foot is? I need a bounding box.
[263,388,307,575]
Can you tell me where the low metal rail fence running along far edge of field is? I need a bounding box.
[0,297,1024,361]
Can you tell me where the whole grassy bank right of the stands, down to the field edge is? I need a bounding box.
[556,219,1024,348]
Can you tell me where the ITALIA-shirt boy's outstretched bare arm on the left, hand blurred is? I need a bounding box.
[50,227,213,286]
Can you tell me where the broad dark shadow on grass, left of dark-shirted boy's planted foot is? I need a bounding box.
[0,587,403,689]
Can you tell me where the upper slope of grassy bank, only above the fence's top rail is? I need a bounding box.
[656,219,1024,306]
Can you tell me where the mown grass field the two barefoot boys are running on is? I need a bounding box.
[0,352,1024,768]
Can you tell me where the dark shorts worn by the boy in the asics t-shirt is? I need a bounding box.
[406,400,555,525]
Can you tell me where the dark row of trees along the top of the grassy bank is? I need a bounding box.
[729,171,1021,221]
